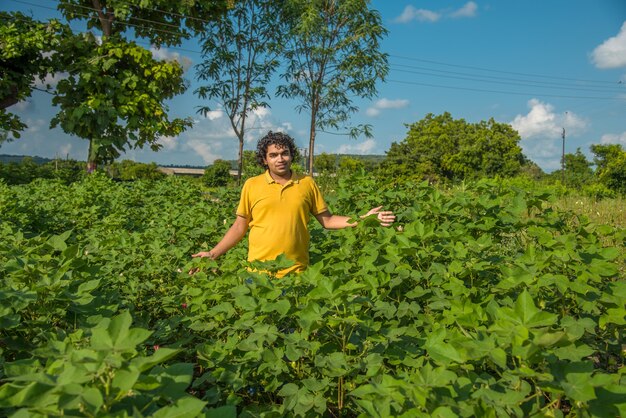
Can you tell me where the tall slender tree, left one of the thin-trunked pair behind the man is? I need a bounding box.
[195,0,285,182]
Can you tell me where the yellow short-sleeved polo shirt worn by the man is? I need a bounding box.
[237,171,327,277]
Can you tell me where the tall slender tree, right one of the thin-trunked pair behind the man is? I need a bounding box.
[277,0,389,172]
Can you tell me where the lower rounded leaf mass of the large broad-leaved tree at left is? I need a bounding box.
[51,35,191,171]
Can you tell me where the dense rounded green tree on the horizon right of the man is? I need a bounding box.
[383,112,524,181]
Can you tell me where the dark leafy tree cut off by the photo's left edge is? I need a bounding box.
[0,12,71,140]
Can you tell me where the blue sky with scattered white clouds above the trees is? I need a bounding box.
[0,0,626,171]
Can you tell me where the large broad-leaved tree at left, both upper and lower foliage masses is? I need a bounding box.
[53,0,230,170]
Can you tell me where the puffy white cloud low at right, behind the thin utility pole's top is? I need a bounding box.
[511,99,587,139]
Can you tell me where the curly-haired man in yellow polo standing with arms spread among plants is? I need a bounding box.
[192,132,396,277]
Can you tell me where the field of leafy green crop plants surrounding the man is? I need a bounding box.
[0,174,626,417]
